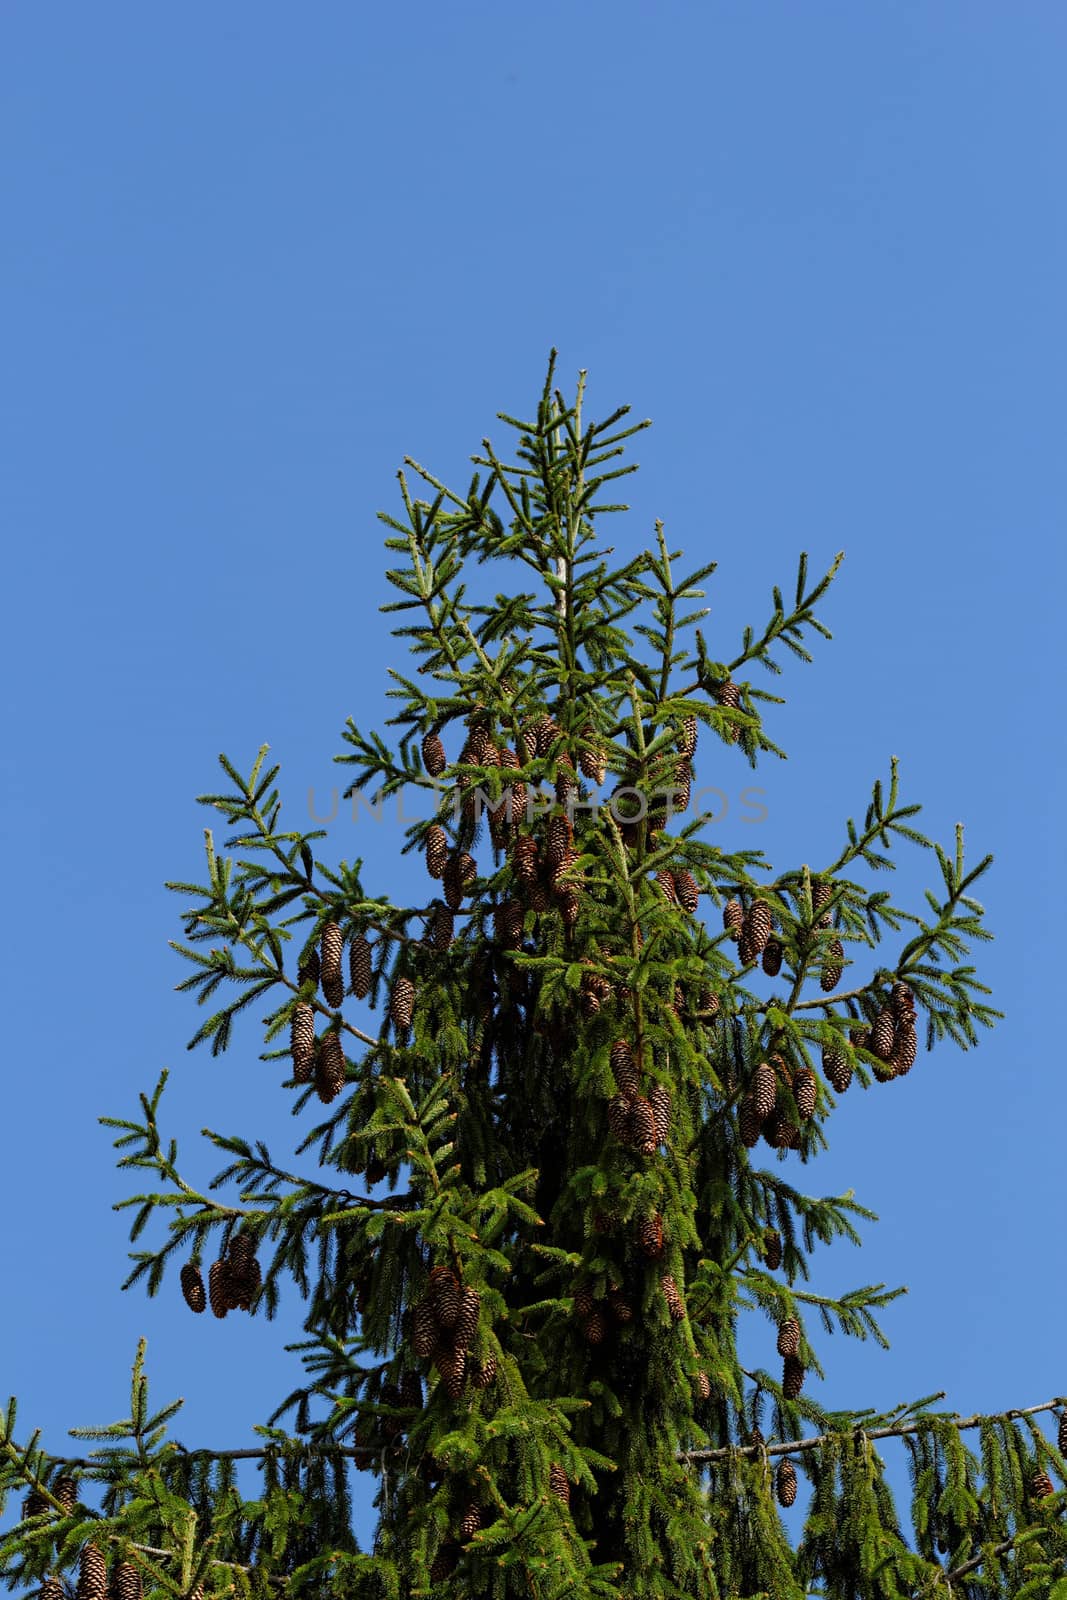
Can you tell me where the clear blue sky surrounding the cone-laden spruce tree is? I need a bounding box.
[0,0,1067,1568]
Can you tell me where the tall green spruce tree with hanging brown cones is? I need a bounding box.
[0,352,1067,1600]
